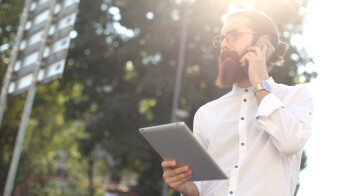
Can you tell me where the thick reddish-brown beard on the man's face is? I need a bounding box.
[216,51,248,88]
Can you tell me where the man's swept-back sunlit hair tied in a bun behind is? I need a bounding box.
[226,10,287,69]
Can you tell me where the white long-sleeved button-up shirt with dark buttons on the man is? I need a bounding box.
[193,78,313,196]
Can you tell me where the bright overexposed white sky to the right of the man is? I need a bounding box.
[298,0,350,196]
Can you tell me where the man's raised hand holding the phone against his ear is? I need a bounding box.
[240,45,269,86]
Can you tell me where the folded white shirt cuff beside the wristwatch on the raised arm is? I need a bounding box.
[256,93,285,118]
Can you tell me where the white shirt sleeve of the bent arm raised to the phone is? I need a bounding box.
[256,86,313,155]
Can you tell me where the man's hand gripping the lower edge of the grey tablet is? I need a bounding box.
[162,160,199,195]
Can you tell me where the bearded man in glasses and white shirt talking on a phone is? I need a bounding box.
[162,10,313,196]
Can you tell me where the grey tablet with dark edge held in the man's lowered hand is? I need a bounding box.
[140,122,227,181]
